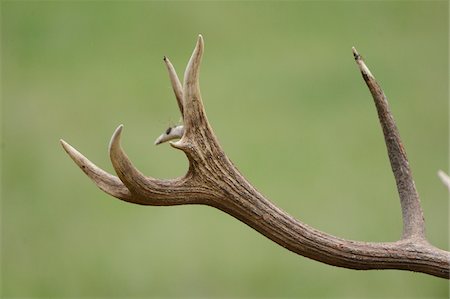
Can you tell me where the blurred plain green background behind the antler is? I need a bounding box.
[1,1,449,298]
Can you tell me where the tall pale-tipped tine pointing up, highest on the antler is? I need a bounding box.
[183,35,209,136]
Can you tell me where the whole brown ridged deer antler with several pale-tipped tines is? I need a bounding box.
[61,36,450,279]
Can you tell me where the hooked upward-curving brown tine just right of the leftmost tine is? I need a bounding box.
[109,125,190,206]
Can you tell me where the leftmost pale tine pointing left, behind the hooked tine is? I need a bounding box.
[60,139,136,202]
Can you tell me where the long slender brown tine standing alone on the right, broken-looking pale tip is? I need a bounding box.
[352,47,425,239]
